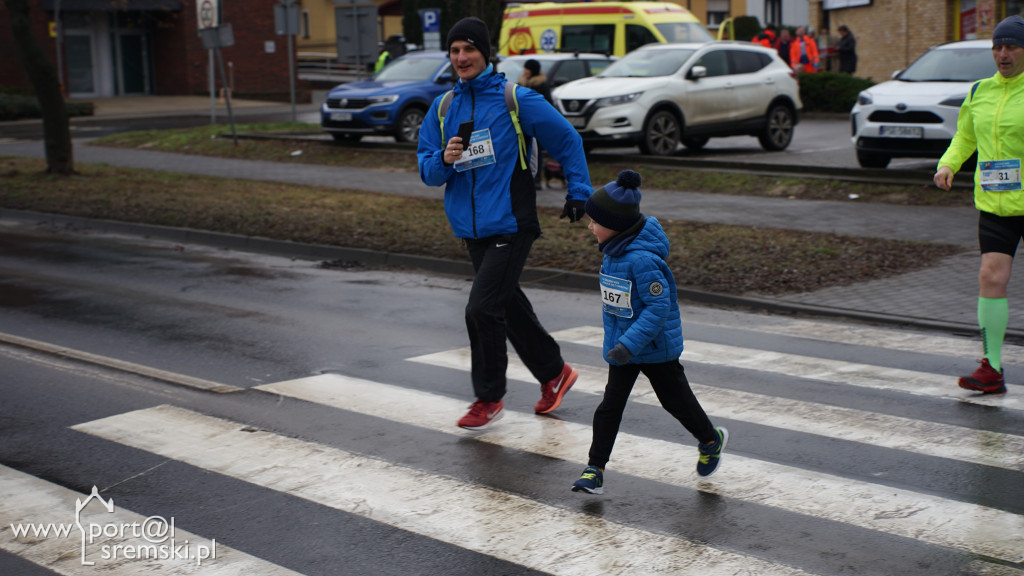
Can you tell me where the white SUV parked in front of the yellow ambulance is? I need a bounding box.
[552,42,803,156]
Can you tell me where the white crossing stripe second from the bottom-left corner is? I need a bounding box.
[74,403,823,576]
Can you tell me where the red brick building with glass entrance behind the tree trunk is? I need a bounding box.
[0,0,304,100]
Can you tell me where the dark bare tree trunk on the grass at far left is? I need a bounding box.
[4,0,75,174]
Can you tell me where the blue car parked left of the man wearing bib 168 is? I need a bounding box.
[321,51,457,142]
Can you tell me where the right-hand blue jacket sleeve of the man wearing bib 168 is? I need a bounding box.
[516,87,594,200]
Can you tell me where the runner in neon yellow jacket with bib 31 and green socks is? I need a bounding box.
[934,16,1024,394]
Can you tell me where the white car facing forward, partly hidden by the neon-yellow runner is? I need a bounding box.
[850,40,996,168]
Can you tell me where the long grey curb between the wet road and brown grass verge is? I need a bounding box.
[0,209,1024,340]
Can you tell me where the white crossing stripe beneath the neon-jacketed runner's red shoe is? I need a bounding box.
[551,326,1024,410]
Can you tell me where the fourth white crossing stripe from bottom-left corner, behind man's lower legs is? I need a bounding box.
[410,348,1024,471]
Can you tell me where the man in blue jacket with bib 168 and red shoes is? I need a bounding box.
[417,17,593,429]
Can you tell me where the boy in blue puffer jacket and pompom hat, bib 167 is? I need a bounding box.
[572,170,729,494]
